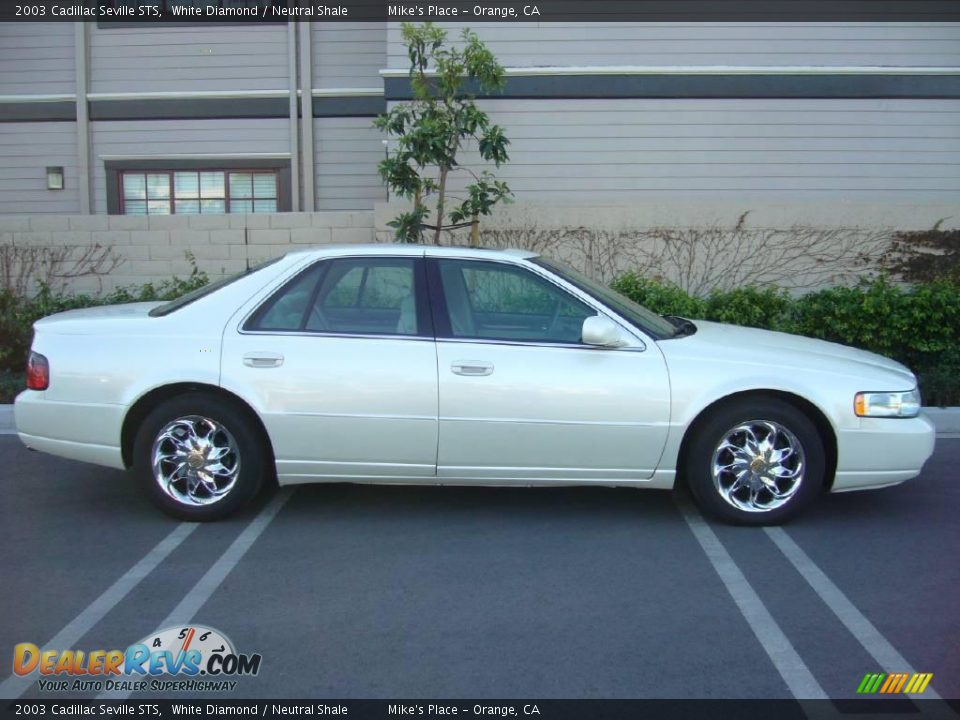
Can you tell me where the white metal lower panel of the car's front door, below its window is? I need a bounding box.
[437,341,670,481]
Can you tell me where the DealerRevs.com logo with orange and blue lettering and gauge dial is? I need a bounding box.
[13,625,263,692]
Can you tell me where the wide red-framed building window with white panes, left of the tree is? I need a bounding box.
[118,170,280,215]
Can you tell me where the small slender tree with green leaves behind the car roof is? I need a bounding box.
[374,23,511,245]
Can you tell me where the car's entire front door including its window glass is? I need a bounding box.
[427,257,670,482]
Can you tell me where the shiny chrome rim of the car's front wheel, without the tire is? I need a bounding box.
[710,420,806,513]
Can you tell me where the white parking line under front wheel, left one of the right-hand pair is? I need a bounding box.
[678,501,828,700]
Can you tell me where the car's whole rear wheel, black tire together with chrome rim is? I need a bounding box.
[133,393,268,522]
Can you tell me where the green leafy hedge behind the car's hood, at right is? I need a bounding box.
[612,273,960,405]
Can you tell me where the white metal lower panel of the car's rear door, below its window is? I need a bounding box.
[223,335,437,482]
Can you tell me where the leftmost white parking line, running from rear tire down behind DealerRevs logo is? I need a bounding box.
[0,523,198,700]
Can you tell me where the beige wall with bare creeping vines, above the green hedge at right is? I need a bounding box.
[374,196,960,294]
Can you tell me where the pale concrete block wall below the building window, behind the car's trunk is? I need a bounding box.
[0,211,375,293]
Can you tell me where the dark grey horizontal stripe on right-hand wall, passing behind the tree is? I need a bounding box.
[384,73,960,100]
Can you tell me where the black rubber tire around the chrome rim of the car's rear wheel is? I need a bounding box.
[133,392,270,522]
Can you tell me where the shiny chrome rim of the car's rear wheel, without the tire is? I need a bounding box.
[150,415,240,505]
